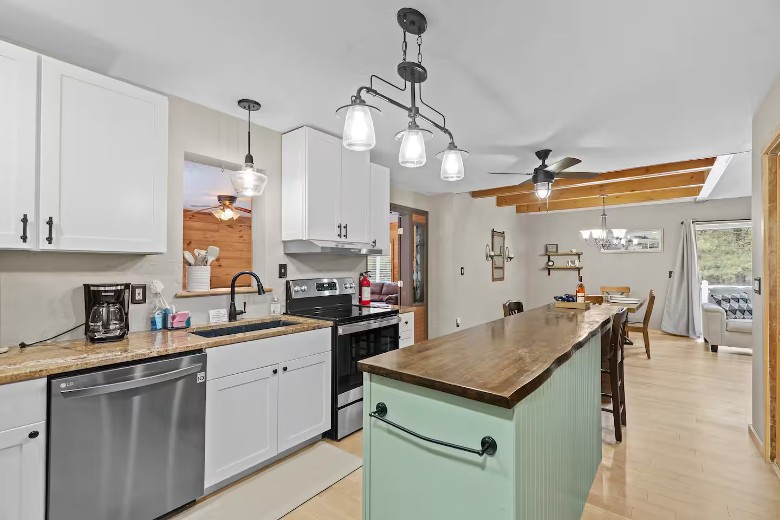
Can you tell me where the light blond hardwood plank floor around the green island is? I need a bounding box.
[285,332,780,520]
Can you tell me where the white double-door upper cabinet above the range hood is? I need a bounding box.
[282,126,371,243]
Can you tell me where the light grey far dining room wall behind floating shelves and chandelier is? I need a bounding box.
[521,198,750,329]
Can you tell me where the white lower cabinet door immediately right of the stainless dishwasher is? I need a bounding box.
[205,365,279,488]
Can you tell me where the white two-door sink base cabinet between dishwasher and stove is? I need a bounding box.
[205,328,331,491]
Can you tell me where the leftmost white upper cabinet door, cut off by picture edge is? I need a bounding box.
[0,42,38,249]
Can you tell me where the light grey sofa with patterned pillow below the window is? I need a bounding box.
[701,286,753,352]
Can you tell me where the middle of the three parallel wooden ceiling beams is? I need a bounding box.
[496,170,709,206]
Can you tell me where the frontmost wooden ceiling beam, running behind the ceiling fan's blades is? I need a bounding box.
[471,157,716,199]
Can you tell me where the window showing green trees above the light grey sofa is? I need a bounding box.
[694,220,753,285]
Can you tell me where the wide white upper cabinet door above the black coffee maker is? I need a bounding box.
[38,57,168,253]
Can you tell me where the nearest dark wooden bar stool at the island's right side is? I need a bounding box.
[601,309,628,442]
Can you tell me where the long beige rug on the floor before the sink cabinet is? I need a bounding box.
[174,442,363,520]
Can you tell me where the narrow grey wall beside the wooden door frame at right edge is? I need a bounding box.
[752,78,780,440]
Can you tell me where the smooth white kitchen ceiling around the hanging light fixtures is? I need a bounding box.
[0,0,780,193]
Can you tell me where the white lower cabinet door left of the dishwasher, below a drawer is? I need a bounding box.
[0,422,46,520]
